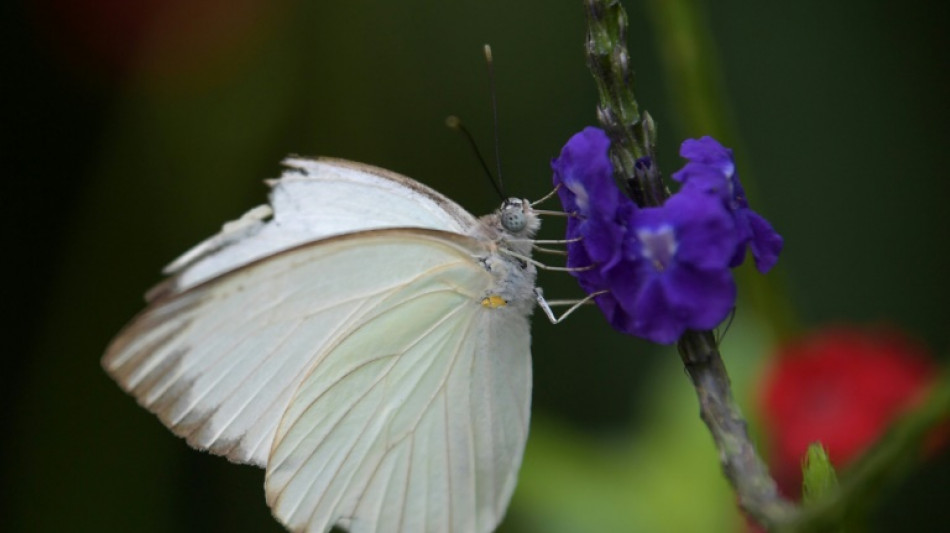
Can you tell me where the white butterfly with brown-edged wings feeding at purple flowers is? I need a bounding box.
[103,158,540,533]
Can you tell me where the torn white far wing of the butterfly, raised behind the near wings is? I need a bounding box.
[162,158,477,299]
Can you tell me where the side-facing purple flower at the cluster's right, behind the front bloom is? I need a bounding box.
[673,136,782,273]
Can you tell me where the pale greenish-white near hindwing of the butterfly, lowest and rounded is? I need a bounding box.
[265,242,531,533]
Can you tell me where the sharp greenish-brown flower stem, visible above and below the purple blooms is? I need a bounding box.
[586,0,796,527]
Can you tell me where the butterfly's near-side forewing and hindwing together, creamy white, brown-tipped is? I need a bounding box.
[103,229,531,532]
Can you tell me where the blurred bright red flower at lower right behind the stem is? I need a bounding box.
[759,326,937,498]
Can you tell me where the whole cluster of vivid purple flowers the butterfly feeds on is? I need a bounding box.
[551,128,782,344]
